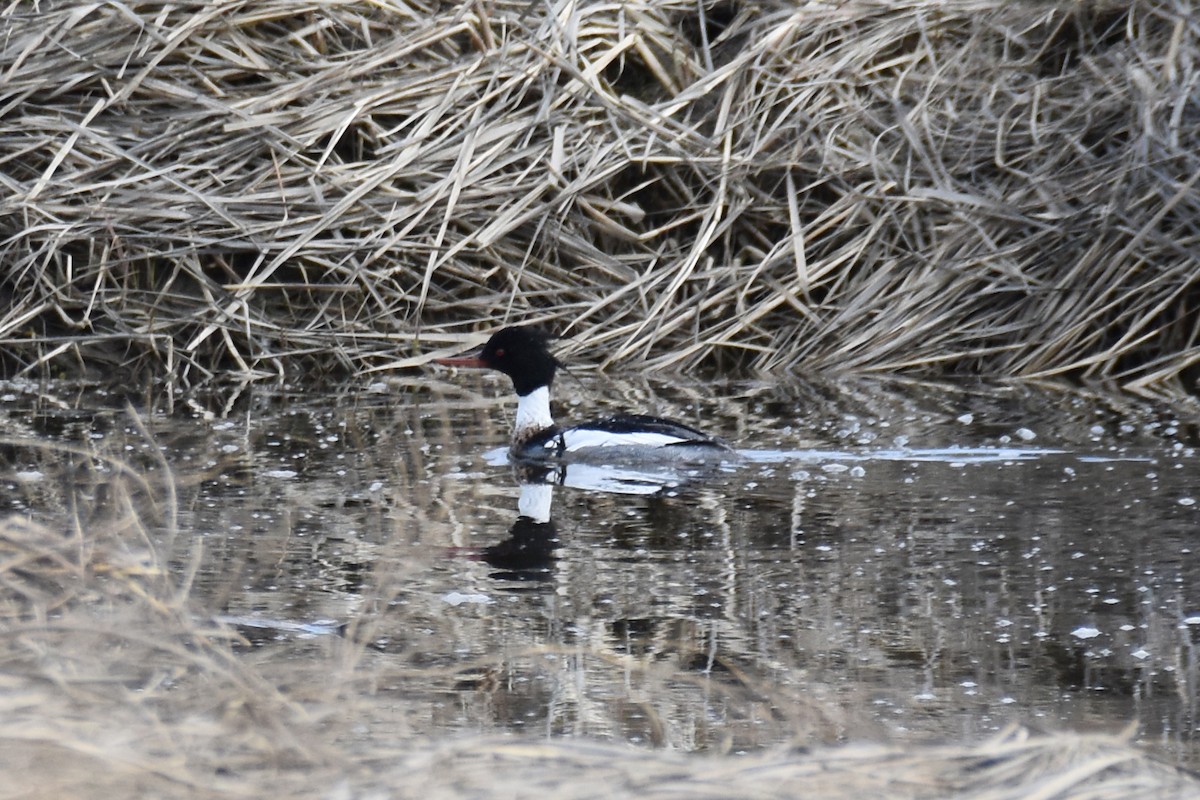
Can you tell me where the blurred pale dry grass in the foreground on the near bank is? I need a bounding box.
[0,422,1200,800]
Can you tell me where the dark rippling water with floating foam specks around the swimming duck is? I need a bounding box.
[0,375,1200,766]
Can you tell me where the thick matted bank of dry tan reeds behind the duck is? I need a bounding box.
[0,0,1200,391]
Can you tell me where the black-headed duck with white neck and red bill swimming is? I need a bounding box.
[434,327,738,463]
